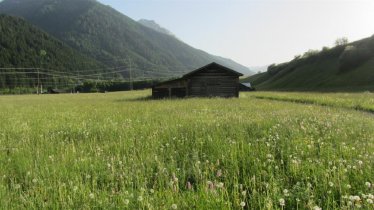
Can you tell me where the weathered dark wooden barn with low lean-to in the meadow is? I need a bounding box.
[152,63,243,98]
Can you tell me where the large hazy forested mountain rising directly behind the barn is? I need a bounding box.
[0,0,253,78]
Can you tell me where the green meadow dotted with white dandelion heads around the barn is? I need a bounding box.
[0,91,374,209]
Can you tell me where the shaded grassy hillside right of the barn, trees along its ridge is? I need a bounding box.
[242,35,374,91]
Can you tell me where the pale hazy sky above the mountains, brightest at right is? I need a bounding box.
[99,0,374,66]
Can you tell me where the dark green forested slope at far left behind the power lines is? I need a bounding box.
[0,15,104,89]
